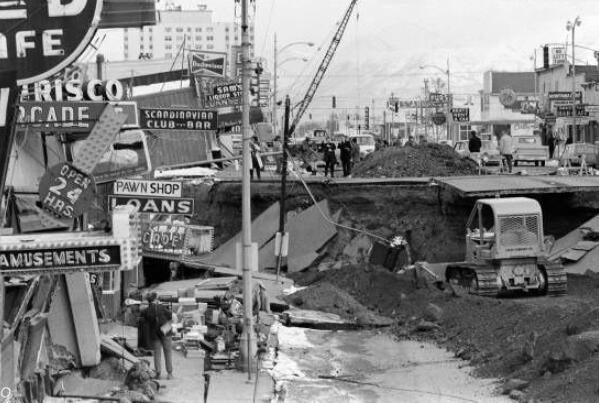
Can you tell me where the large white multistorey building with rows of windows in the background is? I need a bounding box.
[100,5,255,61]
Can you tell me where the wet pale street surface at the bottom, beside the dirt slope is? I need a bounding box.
[273,326,511,403]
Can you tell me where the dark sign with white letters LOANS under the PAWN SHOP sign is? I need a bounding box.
[108,195,193,215]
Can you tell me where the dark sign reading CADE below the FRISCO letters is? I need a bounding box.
[19,101,139,133]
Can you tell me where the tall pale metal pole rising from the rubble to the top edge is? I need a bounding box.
[239,0,257,380]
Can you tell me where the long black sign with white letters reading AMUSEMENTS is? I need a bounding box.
[0,245,121,274]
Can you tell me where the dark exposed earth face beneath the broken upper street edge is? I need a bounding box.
[185,182,599,262]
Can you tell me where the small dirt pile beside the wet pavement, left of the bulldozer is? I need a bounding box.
[285,282,390,326]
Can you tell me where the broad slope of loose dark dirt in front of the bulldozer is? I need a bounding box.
[295,264,599,402]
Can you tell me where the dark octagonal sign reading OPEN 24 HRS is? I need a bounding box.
[39,162,96,218]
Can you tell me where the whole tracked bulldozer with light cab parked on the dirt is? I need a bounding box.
[445,197,567,297]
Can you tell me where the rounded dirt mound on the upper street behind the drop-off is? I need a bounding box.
[352,143,478,178]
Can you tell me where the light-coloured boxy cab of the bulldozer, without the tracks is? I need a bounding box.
[466,197,544,262]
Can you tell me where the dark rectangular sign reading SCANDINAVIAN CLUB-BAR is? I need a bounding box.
[139,108,218,130]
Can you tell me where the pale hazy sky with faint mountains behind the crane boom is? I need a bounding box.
[148,0,599,114]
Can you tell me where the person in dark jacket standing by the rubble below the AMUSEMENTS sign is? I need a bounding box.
[142,292,173,379]
